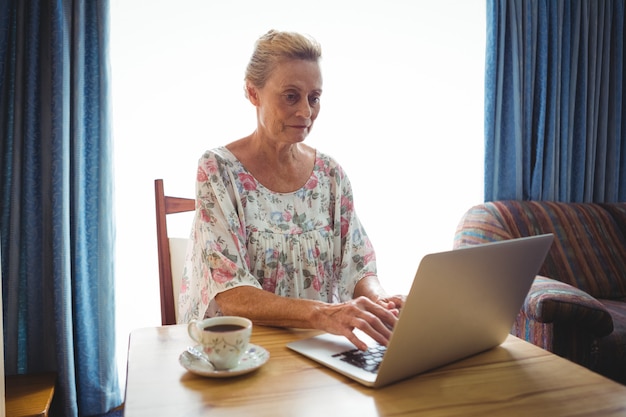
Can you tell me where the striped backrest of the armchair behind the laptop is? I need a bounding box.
[455,201,626,299]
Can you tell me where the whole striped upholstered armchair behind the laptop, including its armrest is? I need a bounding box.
[454,201,626,382]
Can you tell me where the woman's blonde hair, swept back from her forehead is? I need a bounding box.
[245,29,322,92]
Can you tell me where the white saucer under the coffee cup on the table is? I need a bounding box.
[178,343,270,378]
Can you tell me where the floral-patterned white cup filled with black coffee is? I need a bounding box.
[187,316,252,371]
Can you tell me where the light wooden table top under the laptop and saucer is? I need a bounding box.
[124,325,626,417]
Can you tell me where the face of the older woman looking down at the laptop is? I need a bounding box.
[249,60,322,143]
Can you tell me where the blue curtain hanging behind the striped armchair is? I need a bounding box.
[485,0,626,202]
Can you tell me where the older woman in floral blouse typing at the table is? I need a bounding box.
[179,30,404,349]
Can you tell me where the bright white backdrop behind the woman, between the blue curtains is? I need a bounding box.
[111,0,486,390]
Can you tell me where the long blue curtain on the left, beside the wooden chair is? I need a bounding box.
[0,0,122,416]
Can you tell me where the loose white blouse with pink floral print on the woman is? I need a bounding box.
[179,147,376,323]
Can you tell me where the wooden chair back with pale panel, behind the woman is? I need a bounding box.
[154,179,196,325]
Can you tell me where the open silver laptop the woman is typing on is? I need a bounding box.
[287,234,554,387]
